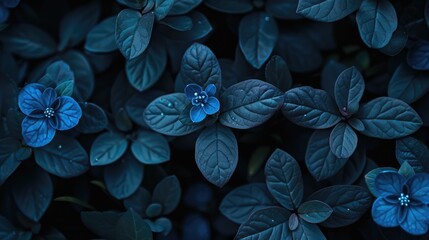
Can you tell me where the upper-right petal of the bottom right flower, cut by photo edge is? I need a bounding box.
[407,173,429,204]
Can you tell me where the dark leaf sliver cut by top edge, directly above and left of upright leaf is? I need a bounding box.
[204,0,253,14]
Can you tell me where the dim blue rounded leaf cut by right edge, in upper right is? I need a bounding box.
[407,41,429,70]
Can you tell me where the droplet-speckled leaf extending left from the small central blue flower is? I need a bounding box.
[143,93,202,136]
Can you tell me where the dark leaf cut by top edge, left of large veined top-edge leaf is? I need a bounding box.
[265,0,302,20]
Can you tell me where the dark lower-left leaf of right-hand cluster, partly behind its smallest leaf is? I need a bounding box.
[305,130,348,181]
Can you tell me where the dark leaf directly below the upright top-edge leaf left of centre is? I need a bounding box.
[125,44,167,92]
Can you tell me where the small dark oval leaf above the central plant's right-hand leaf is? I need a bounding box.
[265,56,292,91]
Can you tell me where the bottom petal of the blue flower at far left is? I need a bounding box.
[22,117,55,147]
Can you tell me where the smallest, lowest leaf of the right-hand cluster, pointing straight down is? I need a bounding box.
[329,122,358,158]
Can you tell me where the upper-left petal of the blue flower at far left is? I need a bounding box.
[18,83,46,115]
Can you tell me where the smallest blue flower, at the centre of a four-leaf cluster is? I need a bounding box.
[185,83,220,123]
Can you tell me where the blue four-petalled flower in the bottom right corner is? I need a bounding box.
[371,172,429,235]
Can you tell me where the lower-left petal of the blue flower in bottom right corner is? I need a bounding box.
[371,197,400,227]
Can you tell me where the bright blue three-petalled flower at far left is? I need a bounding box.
[18,83,82,147]
